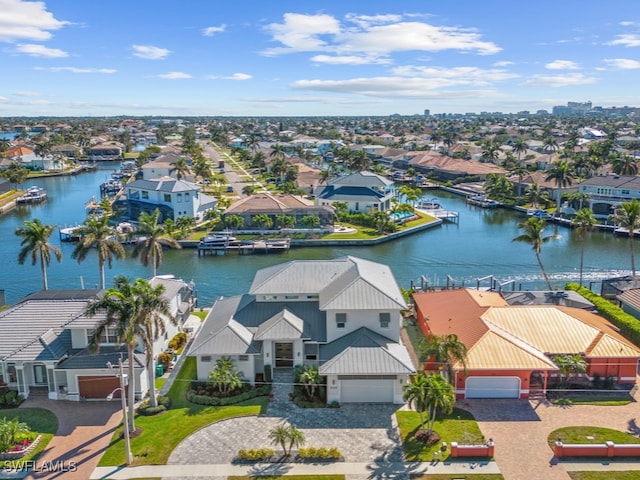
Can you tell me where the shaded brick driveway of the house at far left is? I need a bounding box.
[21,397,122,480]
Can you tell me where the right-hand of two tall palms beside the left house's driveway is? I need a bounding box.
[134,278,178,407]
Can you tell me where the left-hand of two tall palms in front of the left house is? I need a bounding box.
[87,275,143,432]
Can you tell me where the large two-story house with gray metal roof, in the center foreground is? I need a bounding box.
[188,257,415,403]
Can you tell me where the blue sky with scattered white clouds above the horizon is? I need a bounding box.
[0,0,640,116]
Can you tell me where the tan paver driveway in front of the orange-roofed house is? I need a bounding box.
[458,400,640,480]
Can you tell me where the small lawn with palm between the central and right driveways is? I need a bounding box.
[396,408,485,462]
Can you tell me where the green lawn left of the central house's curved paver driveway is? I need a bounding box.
[100,358,269,466]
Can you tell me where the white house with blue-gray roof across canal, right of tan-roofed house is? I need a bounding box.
[314,171,393,213]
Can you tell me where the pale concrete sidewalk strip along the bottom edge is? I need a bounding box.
[91,462,500,480]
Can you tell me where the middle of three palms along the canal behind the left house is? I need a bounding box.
[71,215,125,288]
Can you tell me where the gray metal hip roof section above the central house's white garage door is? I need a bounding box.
[319,327,415,375]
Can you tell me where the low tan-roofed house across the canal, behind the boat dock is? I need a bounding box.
[223,192,334,229]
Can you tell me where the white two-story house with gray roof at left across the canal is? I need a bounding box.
[113,177,218,222]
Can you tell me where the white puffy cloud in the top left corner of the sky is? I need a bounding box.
[0,0,68,42]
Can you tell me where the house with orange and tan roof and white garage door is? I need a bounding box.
[413,289,640,398]
